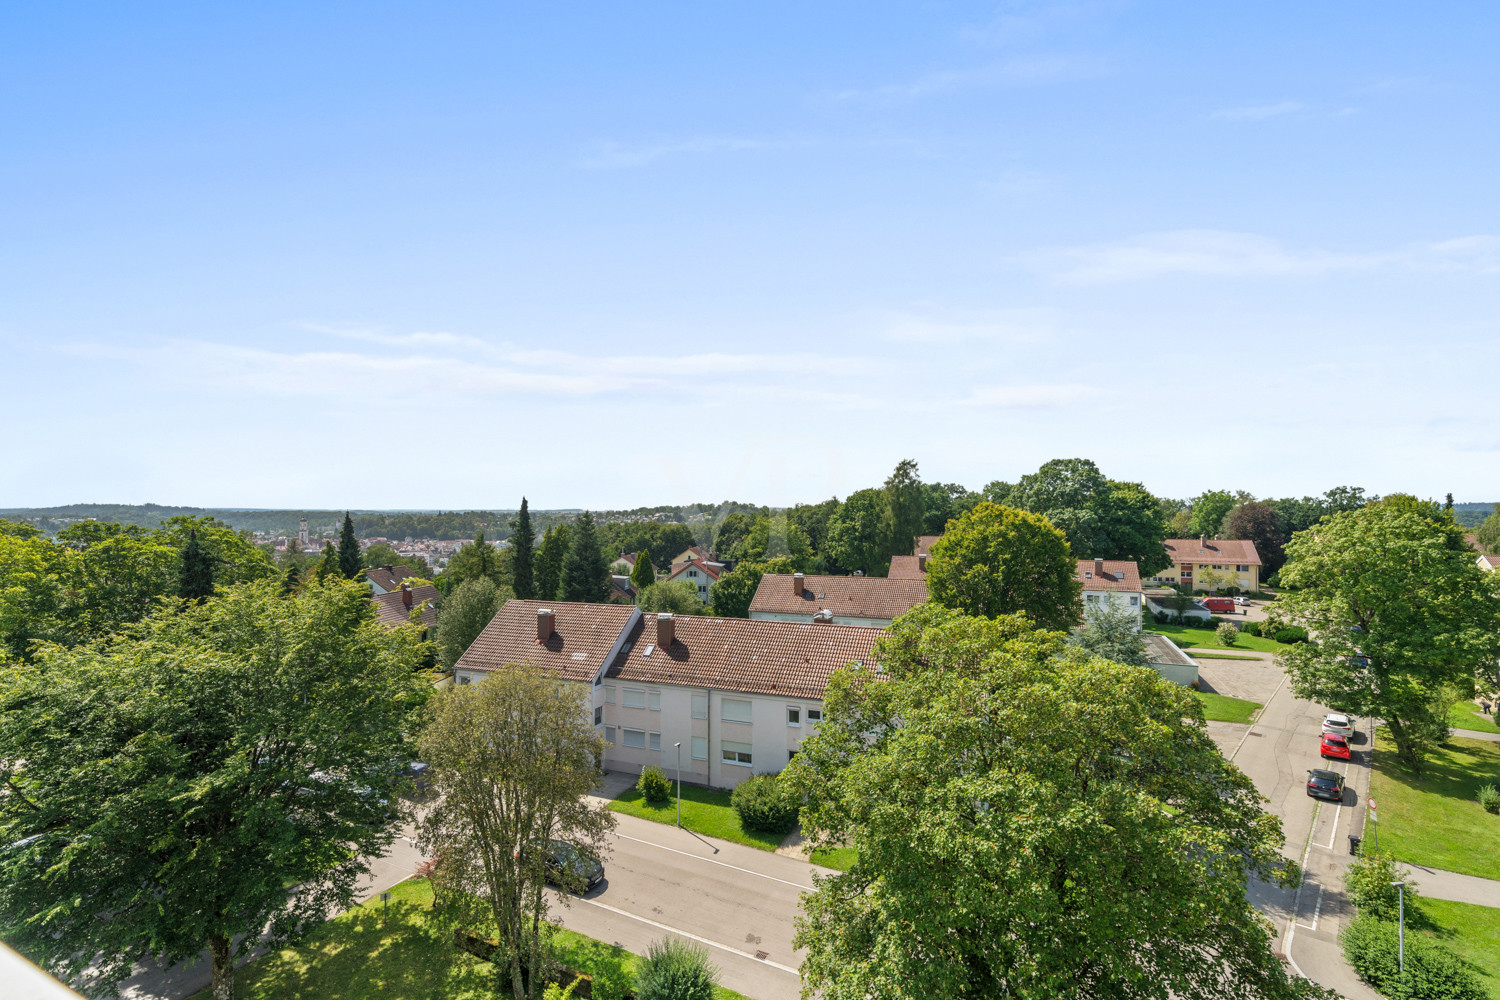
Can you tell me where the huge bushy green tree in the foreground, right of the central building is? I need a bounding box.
[782,602,1299,1000]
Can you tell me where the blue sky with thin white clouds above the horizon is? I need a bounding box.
[0,3,1500,508]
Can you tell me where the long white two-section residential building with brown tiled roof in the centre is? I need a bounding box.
[455,600,881,789]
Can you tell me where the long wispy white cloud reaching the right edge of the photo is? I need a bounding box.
[1016,229,1500,283]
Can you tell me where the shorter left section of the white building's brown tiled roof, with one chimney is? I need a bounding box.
[455,601,638,681]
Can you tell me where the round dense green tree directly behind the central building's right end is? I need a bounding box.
[927,501,1083,628]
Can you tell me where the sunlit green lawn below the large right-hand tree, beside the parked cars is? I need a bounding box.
[1367,727,1500,882]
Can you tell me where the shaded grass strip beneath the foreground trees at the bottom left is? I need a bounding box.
[191,879,747,1000]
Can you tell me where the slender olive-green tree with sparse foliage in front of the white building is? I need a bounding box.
[419,669,615,1000]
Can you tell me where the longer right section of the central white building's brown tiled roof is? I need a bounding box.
[609,615,884,699]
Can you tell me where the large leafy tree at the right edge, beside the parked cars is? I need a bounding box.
[1272,496,1500,772]
